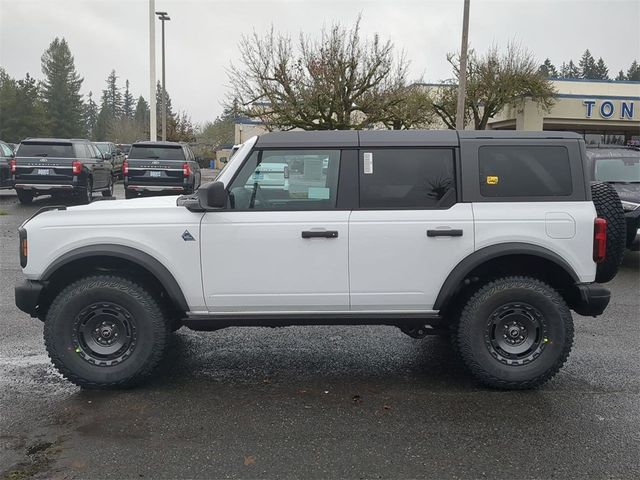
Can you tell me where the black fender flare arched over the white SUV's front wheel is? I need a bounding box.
[41,244,189,312]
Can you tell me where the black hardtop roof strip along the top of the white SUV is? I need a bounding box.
[256,130,582,148]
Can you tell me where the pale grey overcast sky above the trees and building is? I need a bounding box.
[0,0,640,122]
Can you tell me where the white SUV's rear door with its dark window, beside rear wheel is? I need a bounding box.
[349,147,474,312]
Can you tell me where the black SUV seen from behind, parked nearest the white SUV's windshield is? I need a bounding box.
[122,141,201,198]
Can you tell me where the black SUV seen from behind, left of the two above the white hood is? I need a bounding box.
[11,138,113,203]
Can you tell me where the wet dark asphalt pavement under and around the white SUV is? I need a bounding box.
[0,185,640,479]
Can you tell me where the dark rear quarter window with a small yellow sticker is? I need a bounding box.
[478,145,573,197]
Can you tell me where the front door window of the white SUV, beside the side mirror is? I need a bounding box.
[229,150,340,210]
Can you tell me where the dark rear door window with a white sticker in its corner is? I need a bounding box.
[360,148,456,209]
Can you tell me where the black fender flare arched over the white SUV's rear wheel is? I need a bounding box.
[433,242,580,310]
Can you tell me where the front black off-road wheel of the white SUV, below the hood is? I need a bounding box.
[44,275,169,389]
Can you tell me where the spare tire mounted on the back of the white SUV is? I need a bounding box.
[591,182,627,283]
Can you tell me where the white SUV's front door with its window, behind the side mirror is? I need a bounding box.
[201,150,350,313]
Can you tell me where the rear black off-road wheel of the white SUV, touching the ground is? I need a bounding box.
[453,277,573,390]
